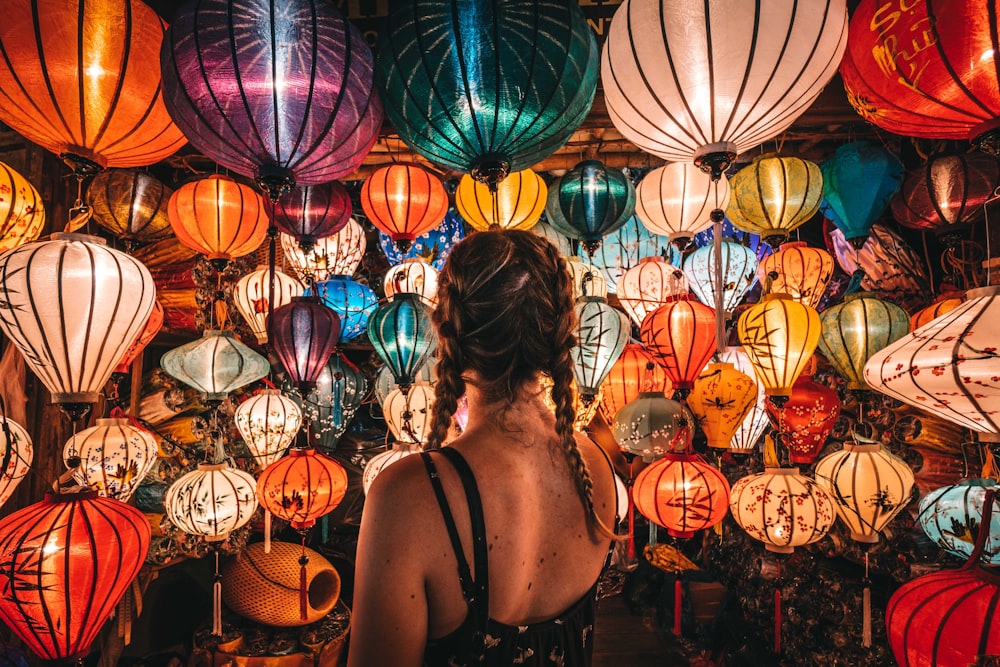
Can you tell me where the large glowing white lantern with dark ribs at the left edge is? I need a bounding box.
[0,234,156,412]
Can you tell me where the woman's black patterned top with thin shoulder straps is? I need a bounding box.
[421,447,600,667]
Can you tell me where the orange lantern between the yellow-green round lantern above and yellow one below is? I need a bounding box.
[757,241,833,308]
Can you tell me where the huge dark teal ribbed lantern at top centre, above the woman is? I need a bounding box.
[376,0,599,185]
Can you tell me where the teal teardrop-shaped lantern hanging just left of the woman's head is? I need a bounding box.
[368,292,437,394]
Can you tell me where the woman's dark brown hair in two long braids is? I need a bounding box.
[427,230,611,535]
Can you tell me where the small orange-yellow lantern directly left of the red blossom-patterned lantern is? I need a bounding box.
[687,363,757,449]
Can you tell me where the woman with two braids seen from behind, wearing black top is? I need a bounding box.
[348,231,615,667]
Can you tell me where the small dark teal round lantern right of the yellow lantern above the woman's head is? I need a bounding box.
[545,160,635,255]
